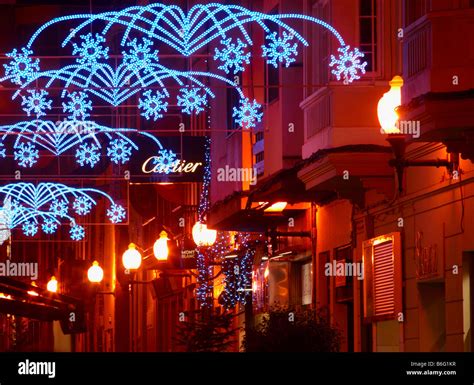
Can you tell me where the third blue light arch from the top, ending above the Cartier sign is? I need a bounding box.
[0,120,163,167]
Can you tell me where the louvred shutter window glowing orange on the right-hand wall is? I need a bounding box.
[362,233,402,320]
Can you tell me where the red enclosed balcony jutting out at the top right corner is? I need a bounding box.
[399,9,474,160]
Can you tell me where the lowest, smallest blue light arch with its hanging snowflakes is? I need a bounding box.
[0,182,126,240]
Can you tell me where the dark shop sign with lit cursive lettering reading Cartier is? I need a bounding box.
[130,136,206,183]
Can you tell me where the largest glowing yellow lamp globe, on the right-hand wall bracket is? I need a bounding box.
[377,76,403,134]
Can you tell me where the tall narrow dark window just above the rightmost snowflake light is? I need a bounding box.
[359,0,377,72]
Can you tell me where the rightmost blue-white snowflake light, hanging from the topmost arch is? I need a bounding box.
[329,45,367,83]
